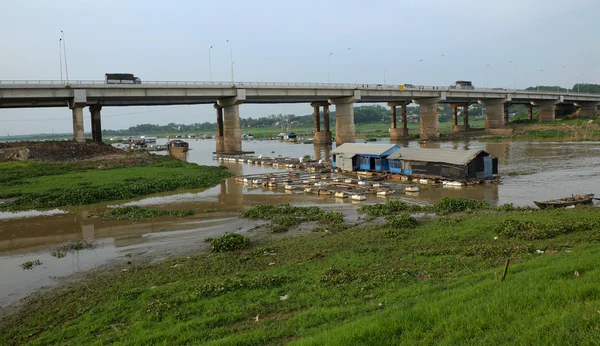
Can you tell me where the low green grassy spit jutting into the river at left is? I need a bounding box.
[0,154,231,211]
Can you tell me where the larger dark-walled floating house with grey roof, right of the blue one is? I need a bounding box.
[388,148,498,181]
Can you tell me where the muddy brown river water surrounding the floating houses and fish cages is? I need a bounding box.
[0,140,600,307]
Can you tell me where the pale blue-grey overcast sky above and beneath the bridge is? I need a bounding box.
[0,0,600,136]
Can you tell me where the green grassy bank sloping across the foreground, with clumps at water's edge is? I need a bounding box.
[0,203,600,345]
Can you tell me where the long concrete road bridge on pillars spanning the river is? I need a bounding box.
[0,81,600,153]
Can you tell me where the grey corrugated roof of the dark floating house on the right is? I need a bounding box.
[388,148,485,165]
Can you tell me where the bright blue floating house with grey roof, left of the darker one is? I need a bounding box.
[331,143,400,171]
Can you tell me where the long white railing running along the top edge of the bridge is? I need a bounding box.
[0,80,598,96]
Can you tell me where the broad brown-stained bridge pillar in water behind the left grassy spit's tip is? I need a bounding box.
[217,89,246,155]
